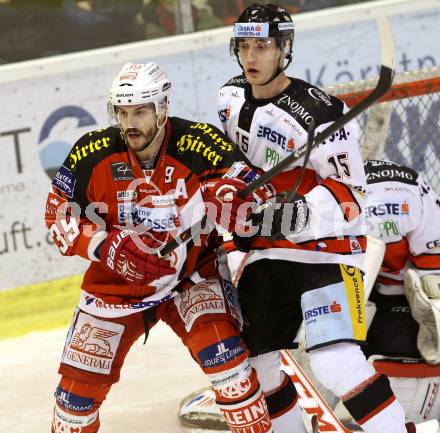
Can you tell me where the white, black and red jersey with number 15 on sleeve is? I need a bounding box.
[218,76,366,268]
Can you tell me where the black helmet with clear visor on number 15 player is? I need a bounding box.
[230,3,295,70]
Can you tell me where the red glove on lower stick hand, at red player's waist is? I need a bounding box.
[99,230,176,285]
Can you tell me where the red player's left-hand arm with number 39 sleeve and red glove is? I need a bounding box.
[45,135,176,285]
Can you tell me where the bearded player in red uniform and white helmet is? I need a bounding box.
[45,63,278,433]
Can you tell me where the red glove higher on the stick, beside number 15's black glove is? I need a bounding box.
[204,179,253,232]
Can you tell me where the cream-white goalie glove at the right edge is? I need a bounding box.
[405,269,440,364]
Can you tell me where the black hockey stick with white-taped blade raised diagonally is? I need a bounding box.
[158,17,394,257]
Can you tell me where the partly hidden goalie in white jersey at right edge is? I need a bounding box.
[364,161,440,422]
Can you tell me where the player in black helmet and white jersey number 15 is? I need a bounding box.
[212,4,407,433]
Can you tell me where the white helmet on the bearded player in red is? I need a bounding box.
[108,62,171,119]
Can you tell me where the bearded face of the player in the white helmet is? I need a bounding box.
[116,104,158,153]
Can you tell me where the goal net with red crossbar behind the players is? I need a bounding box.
[325,67,440,194]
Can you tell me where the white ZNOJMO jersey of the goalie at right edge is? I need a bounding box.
[365,160,440,295]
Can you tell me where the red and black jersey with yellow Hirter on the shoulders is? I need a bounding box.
[45,117,244,317]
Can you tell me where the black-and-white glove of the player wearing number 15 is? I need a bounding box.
[252,194,309,240]
